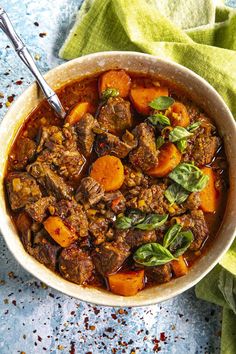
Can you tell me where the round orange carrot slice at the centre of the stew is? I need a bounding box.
[90,155,124,192]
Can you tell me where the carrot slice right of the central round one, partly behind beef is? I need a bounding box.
[147,143,182,177]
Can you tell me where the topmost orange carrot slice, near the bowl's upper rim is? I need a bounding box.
[99,70,131,97]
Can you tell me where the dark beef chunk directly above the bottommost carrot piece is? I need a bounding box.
[92,241,130,276]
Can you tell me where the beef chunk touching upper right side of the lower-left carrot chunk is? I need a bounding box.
[53,200,88,237]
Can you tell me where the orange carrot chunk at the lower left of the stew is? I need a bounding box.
[43,216,78,247]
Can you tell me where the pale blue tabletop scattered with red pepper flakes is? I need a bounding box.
[0,0,236,354]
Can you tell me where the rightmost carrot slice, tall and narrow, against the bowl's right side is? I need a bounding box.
[200,167,218,213]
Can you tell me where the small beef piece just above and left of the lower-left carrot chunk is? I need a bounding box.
[25,196,56,222]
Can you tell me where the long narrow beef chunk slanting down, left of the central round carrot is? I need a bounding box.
[27,161,73,200]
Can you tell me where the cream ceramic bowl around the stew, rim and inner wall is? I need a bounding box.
[0,52,236,306]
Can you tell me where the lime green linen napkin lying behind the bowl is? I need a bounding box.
[59,0,236,354]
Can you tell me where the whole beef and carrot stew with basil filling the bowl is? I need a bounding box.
[5,70,228,296]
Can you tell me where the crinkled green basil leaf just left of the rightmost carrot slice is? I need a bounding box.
[169,163,209,192]
